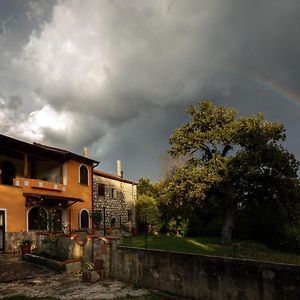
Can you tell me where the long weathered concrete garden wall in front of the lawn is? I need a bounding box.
[111,246,300,300]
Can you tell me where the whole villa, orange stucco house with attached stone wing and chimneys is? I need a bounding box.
[0,134,137,251]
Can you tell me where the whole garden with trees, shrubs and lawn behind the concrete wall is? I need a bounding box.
[133,101,300,264]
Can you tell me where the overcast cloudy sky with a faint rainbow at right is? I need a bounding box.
[0,0,300,180]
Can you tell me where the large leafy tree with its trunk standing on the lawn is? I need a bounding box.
[164,101,298,243]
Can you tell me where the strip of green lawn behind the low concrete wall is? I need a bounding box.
[123,235,300,265]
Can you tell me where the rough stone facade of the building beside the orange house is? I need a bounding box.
[93,170,137,229]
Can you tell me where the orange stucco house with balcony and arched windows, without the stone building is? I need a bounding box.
[0,134,99,251]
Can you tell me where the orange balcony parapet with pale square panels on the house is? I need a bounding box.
[13,177,66,192]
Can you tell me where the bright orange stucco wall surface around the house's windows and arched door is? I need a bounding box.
[0,160,92,232]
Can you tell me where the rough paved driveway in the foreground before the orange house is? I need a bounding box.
[0,254,149,299]
